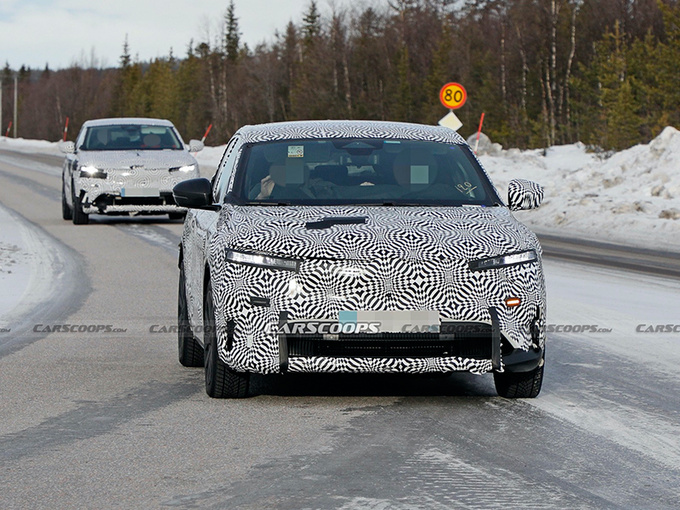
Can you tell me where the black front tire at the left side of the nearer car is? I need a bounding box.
[203,274,250,398]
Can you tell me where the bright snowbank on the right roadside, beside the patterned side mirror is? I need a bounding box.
[480,127,680,251]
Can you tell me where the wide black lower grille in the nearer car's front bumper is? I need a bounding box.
[286,326,491,359]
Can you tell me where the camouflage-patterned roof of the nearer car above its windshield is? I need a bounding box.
[237,120,466,144]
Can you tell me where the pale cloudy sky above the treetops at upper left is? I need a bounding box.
[0,0,342,69]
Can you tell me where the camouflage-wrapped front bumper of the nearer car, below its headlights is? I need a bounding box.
[211,254,545,374]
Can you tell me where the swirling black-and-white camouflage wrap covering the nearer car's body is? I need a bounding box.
[182,121,546,373]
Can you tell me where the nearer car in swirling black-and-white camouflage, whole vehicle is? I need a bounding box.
[174,121,546,398]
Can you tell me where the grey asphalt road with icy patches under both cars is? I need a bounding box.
[0,152,680,510]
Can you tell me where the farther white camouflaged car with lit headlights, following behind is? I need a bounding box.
[60,118,203,225]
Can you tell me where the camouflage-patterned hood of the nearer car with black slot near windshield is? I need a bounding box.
[218,205,540,260]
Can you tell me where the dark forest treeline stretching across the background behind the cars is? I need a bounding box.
[2,0,680,149]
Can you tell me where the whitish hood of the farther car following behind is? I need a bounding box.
[78,150,196,170]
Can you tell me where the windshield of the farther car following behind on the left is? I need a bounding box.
[80,124,183,151]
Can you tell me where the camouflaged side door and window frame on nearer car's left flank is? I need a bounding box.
[183,137,240,342]
